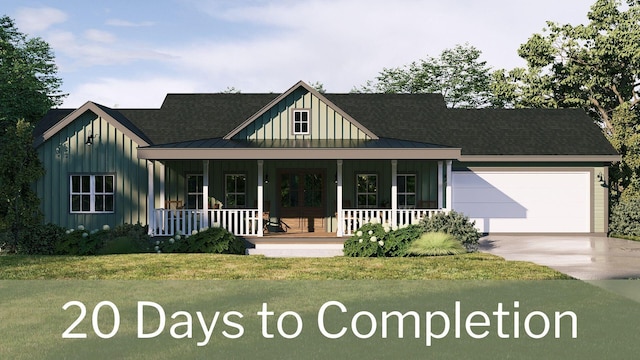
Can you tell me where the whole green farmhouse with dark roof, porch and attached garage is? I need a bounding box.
[34,82,620,237]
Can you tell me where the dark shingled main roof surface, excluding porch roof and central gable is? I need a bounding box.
[35,94,617,155]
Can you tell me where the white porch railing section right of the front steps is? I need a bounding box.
[338,209,446,236]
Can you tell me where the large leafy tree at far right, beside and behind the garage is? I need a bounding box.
[492,0,640,200]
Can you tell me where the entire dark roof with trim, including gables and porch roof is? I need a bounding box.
[34,82,619,162]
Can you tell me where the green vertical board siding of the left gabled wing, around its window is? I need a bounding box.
[36,111,148,229]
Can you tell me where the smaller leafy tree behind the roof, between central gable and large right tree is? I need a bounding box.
[353,44,494,108]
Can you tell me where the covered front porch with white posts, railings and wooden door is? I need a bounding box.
[148,159,452,239]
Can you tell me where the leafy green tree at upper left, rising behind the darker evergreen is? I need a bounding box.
[0,16,65,134]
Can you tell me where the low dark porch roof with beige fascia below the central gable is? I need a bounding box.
[138,138,460,160]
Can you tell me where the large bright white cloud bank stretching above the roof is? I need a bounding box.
[56,0,588,107]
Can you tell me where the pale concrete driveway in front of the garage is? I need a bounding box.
[479,235,640,280]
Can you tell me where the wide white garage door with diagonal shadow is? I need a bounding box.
[452,171,591,233]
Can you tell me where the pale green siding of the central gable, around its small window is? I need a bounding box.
[233,88,369,140]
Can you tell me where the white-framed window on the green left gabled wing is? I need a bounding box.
[70,175,115,213]
